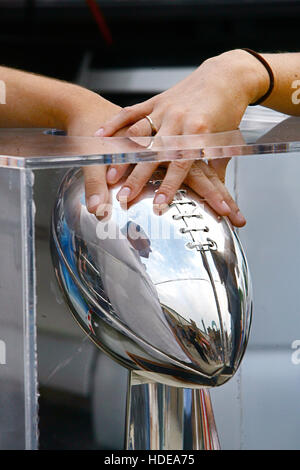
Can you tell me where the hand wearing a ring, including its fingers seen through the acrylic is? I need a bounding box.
[96,50,268,227]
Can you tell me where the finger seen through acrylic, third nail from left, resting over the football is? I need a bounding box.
[117,163,159,205]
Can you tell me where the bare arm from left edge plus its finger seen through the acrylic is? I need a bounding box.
[0,67,122,211]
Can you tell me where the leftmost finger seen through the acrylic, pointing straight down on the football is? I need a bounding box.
[83,165,108,214]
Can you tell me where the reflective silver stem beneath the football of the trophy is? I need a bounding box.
[125,372,220,450]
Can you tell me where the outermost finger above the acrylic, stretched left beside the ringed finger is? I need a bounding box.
[95,100,152,137]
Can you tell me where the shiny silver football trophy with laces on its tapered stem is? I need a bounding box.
[51,169,252,450]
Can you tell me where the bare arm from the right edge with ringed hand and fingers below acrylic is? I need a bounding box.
[96,49,300,226]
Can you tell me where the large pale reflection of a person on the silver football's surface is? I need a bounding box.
[65,194,190,362]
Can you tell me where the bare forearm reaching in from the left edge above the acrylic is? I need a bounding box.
[0,67,119,135]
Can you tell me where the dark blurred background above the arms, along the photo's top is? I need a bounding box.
[0,0,300,106]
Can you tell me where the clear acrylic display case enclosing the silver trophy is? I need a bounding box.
[0,107,300,449]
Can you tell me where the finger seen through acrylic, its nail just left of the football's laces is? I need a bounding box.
[153,160,193,210]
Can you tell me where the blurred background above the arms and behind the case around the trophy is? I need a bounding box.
[0,0,300,449]
